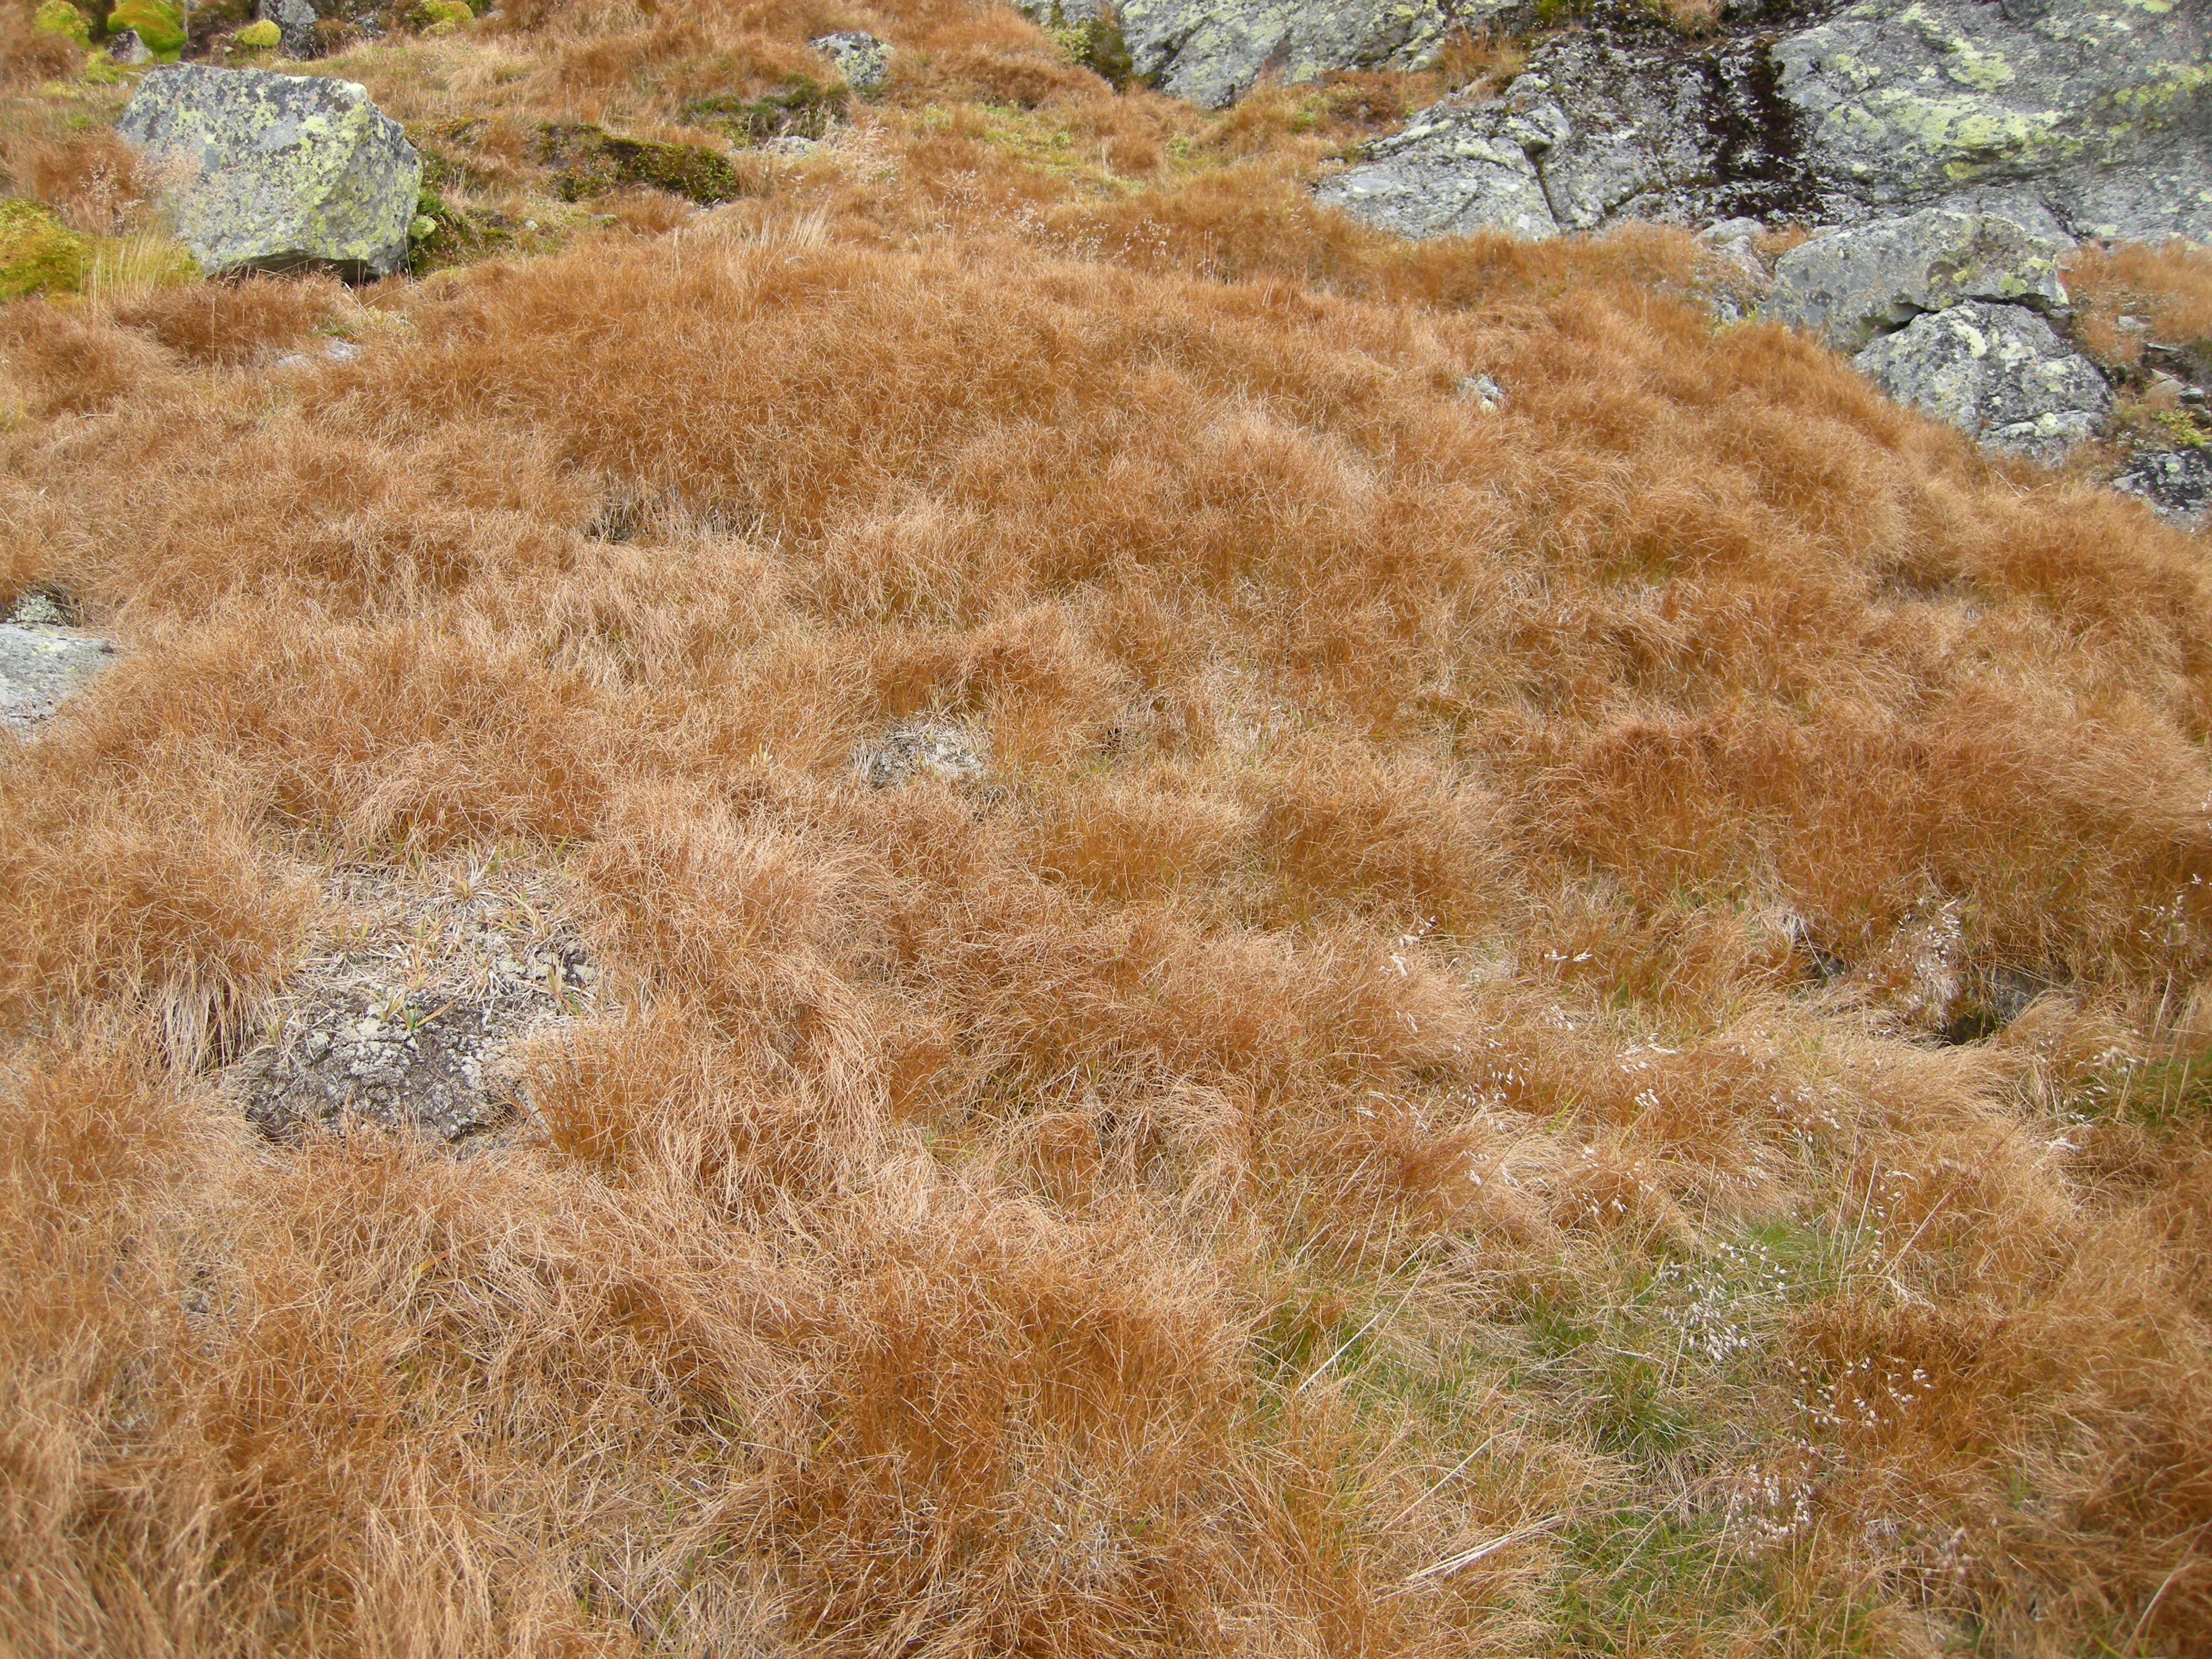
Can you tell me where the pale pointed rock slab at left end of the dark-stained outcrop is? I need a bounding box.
[1314,97,1566,239]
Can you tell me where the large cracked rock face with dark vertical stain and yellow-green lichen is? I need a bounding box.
[1310,0,2212,241]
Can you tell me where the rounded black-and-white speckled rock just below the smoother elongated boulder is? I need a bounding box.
[1851,301,2112,462]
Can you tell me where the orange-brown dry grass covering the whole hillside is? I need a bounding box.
[0,0,2212,1659]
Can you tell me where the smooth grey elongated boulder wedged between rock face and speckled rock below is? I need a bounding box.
[1761,208,2070,352]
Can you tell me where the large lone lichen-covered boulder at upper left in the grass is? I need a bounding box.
[117,64,422,276]
